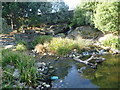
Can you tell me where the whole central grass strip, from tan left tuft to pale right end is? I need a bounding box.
[35,37,92,56]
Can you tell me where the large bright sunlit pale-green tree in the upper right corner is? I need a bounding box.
[94,2,120,33]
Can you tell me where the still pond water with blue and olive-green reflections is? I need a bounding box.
[39,55,120,88]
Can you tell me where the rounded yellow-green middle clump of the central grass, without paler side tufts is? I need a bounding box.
[48,38,75,55]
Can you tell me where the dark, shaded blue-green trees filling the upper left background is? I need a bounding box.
[2,2,69,29]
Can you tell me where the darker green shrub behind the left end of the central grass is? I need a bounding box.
[31,35,52,48]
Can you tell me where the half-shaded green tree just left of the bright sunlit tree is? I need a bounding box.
[73,2,98,25]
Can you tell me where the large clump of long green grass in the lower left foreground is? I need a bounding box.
[2,49,37,87]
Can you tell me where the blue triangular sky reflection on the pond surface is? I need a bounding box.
[53,65,98,88]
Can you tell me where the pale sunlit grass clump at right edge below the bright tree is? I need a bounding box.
[99,34,120,50]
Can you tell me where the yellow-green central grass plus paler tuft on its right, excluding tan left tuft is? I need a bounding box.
[49,38,92,55]
